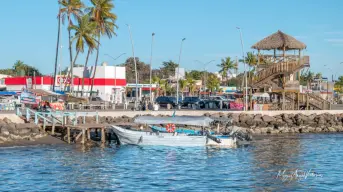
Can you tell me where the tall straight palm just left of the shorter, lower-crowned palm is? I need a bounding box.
[59,0,84,92]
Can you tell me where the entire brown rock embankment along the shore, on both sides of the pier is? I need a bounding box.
[0,112,343,146]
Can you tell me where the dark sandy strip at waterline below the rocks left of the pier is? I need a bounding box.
[0,135,66,147]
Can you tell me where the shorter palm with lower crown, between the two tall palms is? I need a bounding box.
[70,15,96,95]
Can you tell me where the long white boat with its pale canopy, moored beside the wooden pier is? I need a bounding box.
[112,116,242,147]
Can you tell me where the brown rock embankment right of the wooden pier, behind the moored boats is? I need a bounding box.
[78,112,343,135]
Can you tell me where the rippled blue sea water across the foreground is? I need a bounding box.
[0,134,343,191]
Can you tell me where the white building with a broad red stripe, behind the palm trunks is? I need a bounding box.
[5,64,126,103]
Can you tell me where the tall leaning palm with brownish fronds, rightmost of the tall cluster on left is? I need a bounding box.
[87,0,118,97]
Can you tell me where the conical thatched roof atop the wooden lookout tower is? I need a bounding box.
[251,30,306,50]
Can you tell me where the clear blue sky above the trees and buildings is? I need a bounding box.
[0,0,343,77]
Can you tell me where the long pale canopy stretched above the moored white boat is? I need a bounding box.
[134,116,213,127]
